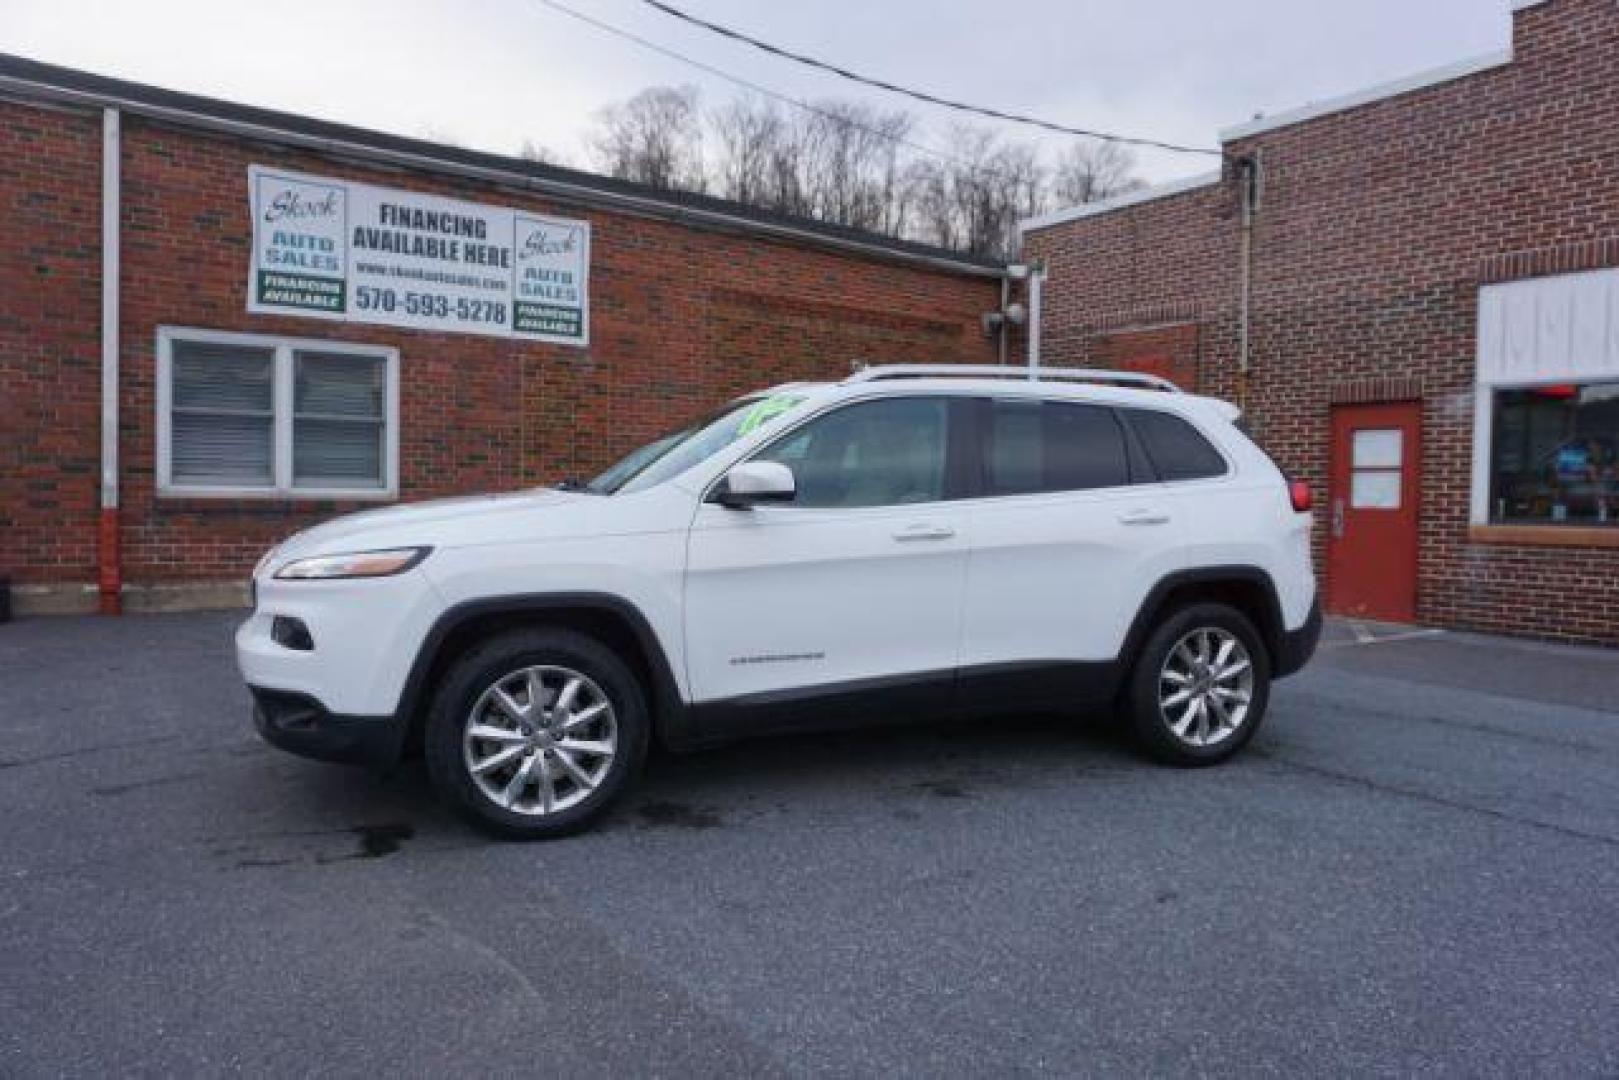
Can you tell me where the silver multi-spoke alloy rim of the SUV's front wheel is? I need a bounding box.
[461,665,618,816]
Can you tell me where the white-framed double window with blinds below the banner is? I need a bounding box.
[157,327,398,497]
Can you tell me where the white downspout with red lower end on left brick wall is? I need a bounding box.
[99,108,123,615]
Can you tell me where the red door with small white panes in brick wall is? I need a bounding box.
[1326,402,1421,622]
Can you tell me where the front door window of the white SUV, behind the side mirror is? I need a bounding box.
[754,397,949,507]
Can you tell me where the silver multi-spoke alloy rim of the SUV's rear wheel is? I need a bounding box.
[1158,627,1253,746]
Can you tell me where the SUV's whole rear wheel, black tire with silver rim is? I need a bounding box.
[1124,602,1271,766]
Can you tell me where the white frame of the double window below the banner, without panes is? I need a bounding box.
[155,325,400,502]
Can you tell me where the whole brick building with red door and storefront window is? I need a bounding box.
[1023,0,1619,644]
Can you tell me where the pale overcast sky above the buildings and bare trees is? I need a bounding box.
[0,0,1511,189]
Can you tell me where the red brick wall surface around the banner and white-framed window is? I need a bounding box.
[0,102,999,605]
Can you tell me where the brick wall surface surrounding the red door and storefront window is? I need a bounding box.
[1025,0,1619,644]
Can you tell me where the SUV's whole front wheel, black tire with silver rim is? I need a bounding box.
[426,628,651,840]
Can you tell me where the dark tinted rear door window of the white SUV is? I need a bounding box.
[983,398,1130,495]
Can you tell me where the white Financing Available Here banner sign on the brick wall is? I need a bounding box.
[248,165,591,345]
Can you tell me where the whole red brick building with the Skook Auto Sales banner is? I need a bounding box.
[0,57,1004,610]
